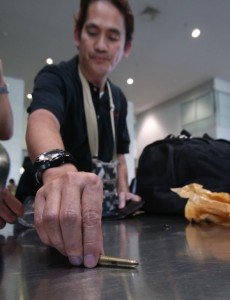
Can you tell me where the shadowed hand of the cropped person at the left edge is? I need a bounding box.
[0,188,23,228]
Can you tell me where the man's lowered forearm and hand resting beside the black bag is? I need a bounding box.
[117,154,141,208]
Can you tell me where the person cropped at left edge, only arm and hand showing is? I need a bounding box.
[0,59,23,228]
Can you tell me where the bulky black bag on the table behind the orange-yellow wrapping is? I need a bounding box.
[137,130,230,215]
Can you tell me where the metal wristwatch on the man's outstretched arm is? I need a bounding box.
[34,149,76,185]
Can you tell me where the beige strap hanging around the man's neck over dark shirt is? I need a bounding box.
[78,66,116,160]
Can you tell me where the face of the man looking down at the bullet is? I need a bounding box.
[75,1,131,81]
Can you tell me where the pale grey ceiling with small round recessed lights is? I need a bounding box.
[0,0,230,114]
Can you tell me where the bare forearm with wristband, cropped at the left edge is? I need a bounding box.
[0,59,13,140]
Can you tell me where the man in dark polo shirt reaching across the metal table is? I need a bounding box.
[26,0,140,268]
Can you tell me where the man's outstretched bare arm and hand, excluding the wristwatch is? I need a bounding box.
[26,109,104,268]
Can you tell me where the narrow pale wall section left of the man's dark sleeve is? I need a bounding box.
[1,77,25,183]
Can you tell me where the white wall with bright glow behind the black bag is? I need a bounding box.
[135,79,230,160]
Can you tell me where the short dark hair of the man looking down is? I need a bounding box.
[75,0,134,45]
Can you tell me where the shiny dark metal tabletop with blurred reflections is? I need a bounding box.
[0,215,230,300]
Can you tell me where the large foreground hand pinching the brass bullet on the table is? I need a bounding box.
[34,168,103,268]
